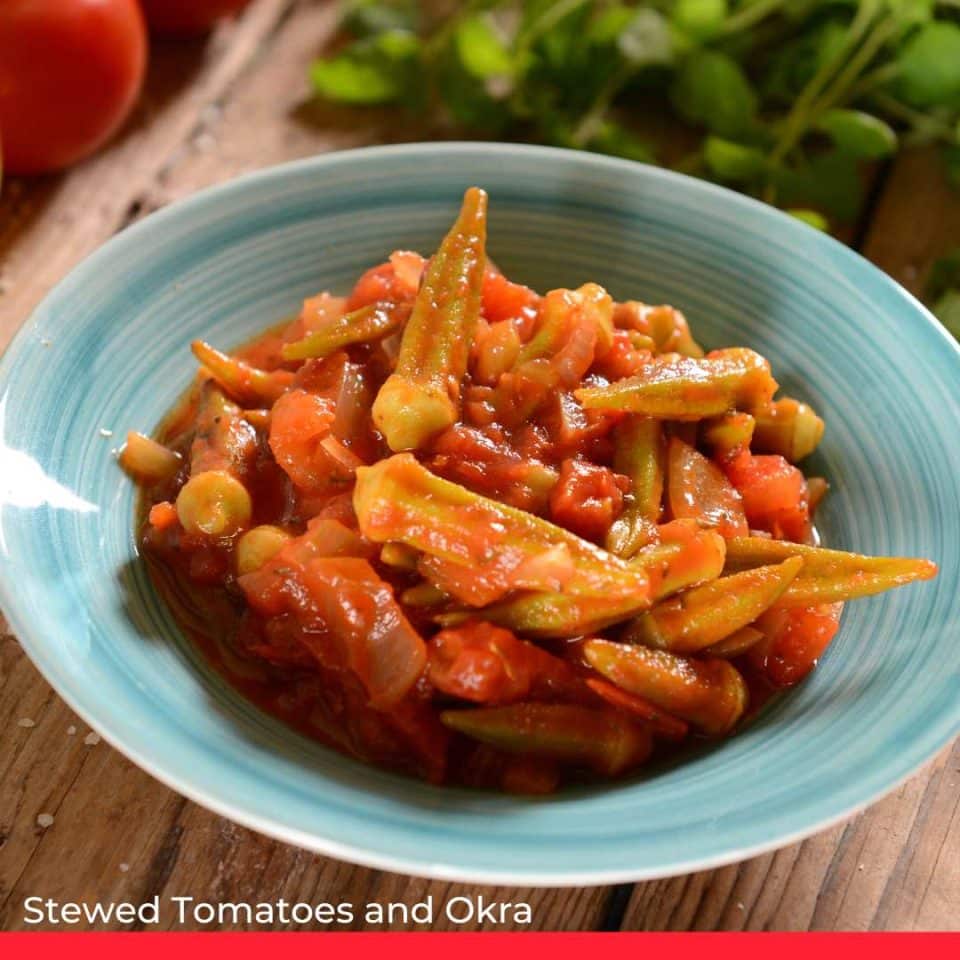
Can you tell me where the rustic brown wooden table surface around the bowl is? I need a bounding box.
[0,0,960,930]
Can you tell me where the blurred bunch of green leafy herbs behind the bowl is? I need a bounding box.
[311,0,960,240]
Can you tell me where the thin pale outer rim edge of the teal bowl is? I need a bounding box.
[0,141,960,888]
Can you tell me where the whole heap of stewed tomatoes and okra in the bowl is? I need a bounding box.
[122,188,936,792]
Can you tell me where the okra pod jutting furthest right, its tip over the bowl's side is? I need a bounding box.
[727,537,937,607]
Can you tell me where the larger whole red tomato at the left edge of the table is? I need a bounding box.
[0,0,147,173]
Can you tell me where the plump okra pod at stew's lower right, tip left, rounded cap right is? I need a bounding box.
[583,640,748,736]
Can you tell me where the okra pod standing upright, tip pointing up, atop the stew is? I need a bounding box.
[373,187,487,450]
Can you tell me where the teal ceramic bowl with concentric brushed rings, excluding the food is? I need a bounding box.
[0,144,960,886]
